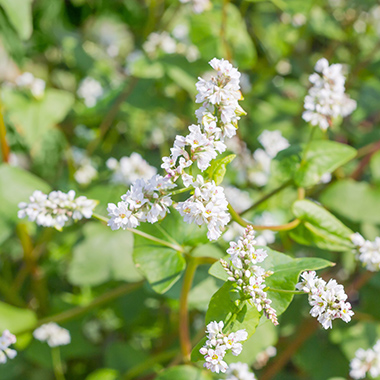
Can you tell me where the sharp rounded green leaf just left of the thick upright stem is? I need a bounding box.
[133,242,186,293]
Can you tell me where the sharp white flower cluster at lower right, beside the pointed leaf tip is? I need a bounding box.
[296,271,354,329]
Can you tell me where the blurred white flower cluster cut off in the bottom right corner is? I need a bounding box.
[350,340,380,379]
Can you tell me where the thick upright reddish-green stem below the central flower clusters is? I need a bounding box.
[179,256,199,363]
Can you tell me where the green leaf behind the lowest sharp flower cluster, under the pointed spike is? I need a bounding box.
[191,281,261,361]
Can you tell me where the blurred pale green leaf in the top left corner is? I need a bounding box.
[0,0,33,40]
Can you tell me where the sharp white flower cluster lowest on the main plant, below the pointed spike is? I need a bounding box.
[199,321,248,373]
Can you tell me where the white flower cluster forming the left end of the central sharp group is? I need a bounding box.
[107,174,176,230]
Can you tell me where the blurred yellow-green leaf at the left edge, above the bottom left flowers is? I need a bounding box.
[0,301,37,334]
